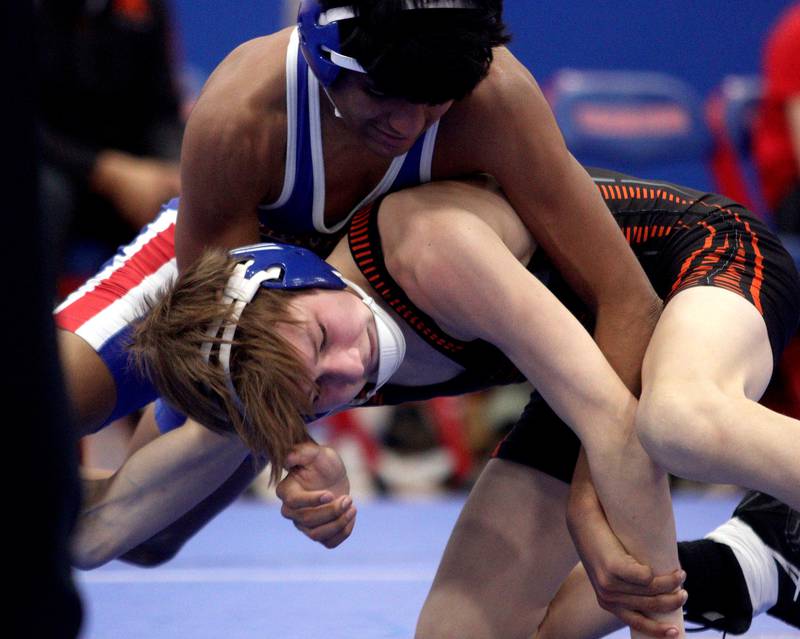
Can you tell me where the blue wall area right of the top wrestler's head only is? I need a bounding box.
[505,0,791,93]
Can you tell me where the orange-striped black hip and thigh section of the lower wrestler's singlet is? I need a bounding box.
[590,170,800,361]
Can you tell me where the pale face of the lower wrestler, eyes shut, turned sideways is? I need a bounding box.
[276,289,379,414]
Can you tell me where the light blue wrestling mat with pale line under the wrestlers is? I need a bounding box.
[78,496,800,639]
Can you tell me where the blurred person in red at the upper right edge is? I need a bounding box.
[753,3,800,234]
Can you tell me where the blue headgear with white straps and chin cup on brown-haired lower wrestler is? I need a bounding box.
[200,243,406,419]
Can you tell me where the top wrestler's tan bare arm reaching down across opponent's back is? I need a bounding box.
[435,49,661,393]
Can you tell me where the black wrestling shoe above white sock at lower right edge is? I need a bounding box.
[733,491,800,628]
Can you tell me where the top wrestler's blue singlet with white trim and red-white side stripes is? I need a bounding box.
[56,29,438,432]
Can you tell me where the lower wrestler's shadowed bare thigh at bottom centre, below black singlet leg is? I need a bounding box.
[417,459,577,639]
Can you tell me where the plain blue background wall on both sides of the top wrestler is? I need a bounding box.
[172,0,790,93]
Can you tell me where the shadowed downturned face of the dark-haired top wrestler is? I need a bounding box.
[328,71,453,158]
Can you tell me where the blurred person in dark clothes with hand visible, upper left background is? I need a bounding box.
[35,0,183,294]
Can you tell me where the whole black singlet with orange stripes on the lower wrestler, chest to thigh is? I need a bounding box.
[348,169,800,403]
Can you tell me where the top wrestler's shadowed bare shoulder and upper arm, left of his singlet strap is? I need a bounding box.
[175,35,286,269]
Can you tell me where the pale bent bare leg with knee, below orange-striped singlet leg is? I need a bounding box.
[636,286,800,509]
